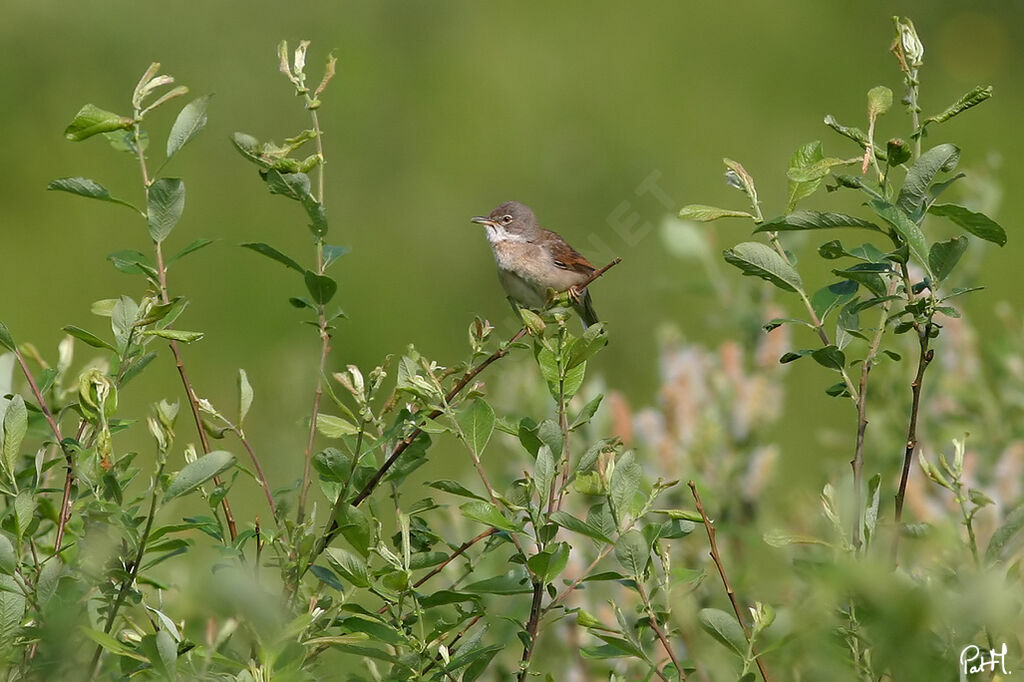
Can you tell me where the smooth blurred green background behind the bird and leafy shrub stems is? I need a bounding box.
[0,0,1024,503]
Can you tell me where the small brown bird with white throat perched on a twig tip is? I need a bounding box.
[472,202,599,329]
